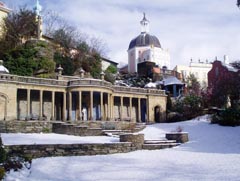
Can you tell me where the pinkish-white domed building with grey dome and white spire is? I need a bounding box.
[128,13,170,73]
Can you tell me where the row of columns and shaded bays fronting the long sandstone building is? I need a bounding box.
[17,89,148,122]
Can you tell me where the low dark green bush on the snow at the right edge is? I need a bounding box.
[211,108,240,126]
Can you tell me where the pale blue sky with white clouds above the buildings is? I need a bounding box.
[2,0,240,68]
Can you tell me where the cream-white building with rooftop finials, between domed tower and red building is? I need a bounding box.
[174,60,212,87]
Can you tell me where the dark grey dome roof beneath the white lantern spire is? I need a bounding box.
[128,33,161,50]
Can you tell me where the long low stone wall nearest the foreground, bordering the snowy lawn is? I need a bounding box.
[4,143,137,158]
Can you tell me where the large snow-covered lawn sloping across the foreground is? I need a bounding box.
[3,116,240,181]
